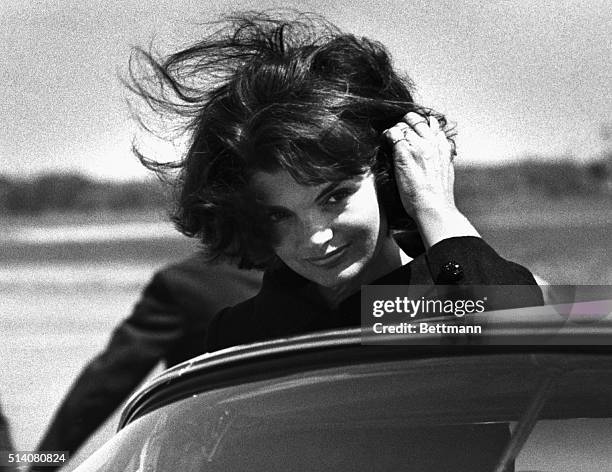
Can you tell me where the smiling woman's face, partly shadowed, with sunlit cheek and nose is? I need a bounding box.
[251,171,387,287]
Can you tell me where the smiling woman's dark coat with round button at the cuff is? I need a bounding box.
[206,236,543,352]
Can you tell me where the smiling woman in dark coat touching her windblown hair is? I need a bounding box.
[130,14,541,351]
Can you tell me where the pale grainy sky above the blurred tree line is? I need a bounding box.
[0,0,612,179]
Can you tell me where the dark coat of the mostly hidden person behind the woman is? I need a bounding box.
[39,254,261,460]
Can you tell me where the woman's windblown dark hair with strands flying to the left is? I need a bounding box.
[125,12,452,268]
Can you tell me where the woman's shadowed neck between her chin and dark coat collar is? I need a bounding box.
[318,236,412,308]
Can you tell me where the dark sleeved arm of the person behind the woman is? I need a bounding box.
[39,272,183,460]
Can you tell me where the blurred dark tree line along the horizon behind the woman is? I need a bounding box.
[0,156,612,215]
